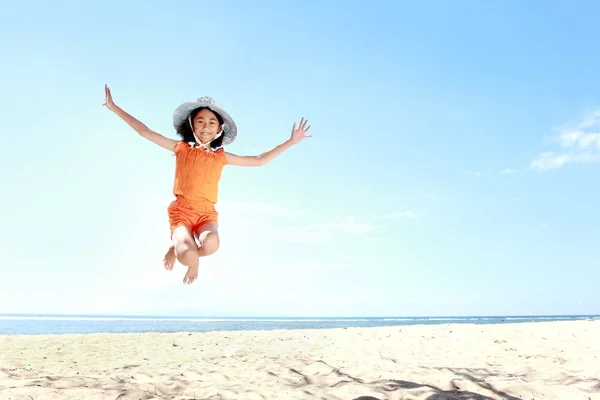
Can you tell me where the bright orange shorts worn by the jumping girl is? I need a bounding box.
[168,198,219,236]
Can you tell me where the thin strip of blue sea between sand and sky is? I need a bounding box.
[0,314,600,335]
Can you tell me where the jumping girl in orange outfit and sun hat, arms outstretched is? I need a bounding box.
[103,85,312,284]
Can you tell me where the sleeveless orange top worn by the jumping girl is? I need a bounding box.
[173,141,227,204]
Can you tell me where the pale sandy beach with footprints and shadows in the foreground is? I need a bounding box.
[0,320,600,400]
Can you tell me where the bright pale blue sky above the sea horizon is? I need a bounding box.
[0,1,600,316]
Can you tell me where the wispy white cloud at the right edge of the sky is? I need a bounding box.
[530,110,600,172]
